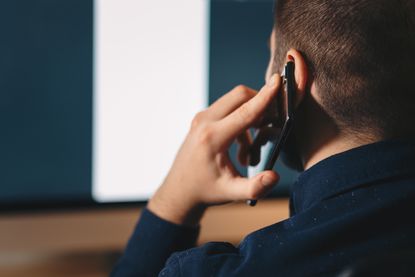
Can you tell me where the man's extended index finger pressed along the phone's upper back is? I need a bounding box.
[215,74,281,145]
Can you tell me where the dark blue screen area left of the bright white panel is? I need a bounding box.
[0,0,93,208]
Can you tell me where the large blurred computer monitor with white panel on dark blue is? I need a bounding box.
[0,0,295,210]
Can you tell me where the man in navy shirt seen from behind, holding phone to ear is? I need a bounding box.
[113,0,415,276]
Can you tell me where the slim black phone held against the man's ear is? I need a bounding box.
[247,61,296,206]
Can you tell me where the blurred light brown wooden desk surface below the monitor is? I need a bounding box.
[0,199,288,277]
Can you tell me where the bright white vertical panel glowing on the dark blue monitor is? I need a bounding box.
[92,0,209,202]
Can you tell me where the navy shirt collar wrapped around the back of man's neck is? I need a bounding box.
[291,140,415,213]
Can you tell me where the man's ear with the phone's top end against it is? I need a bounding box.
[286,49,308,102]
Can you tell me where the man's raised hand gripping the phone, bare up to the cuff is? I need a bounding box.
[148,75,281,225]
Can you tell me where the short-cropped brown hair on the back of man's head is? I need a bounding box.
[273,0,415,137]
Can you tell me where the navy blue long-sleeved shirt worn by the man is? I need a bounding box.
[113,141,415,276]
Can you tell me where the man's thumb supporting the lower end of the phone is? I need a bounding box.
[224,170,279,201]
